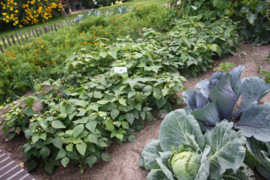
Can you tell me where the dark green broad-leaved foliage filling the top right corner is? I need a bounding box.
[180,0,270,45]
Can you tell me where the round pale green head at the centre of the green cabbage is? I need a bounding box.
[169,145,201,180]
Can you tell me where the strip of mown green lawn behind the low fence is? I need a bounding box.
[0,0,170,45]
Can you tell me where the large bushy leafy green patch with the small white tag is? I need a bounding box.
[1,32,188,174]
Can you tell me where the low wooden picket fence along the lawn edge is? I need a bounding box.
[0,19,73,53]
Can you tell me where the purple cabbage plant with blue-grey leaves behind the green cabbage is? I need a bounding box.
[183,66,270,142]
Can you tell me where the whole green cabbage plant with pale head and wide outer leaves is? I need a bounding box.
[139,110,253,180]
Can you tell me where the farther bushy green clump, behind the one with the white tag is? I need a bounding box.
[164,16,239,77]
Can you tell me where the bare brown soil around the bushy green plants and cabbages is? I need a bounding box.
[0,44,270,180]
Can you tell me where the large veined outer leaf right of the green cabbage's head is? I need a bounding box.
[204,120,246,179]
